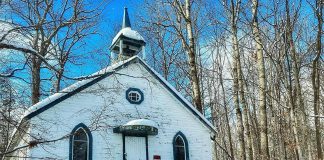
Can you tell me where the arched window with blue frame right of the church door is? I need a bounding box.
[173,132,189,160]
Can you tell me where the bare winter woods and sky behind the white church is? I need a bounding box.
[0,0,324,160]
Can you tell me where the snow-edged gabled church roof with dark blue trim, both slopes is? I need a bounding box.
[24,56,216,132]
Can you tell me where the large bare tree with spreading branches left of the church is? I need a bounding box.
[0,0,99,104]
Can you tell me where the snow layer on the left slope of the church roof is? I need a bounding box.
[23,56,136,118]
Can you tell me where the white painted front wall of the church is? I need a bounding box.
[17,63,212,160]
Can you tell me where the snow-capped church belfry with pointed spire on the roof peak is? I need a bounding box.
[109,8,146,61]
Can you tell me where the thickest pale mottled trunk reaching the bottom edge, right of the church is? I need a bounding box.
[252,0,270,159]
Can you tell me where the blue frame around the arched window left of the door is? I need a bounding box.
[69,123,92,160]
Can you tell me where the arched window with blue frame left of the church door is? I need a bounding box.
[70,123,92,160]
